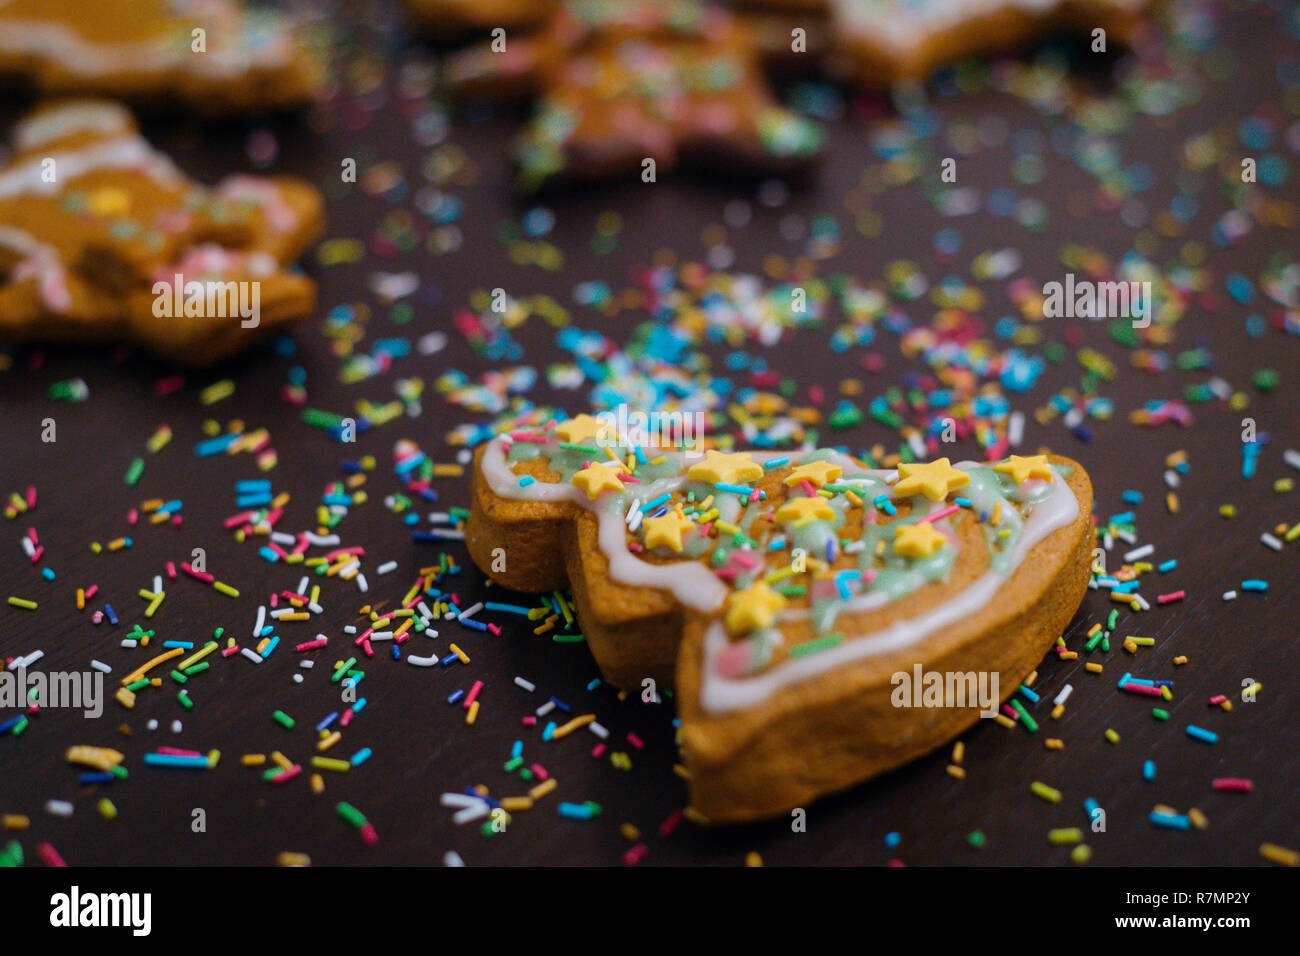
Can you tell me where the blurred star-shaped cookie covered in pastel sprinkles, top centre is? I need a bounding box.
[447,0,822,190]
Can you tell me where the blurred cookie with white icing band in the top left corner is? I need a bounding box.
[0,0,324,113]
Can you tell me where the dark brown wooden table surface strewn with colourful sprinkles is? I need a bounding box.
[0,4,1300,865]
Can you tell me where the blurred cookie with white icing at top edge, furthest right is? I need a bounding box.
[828,0,1149,83]
